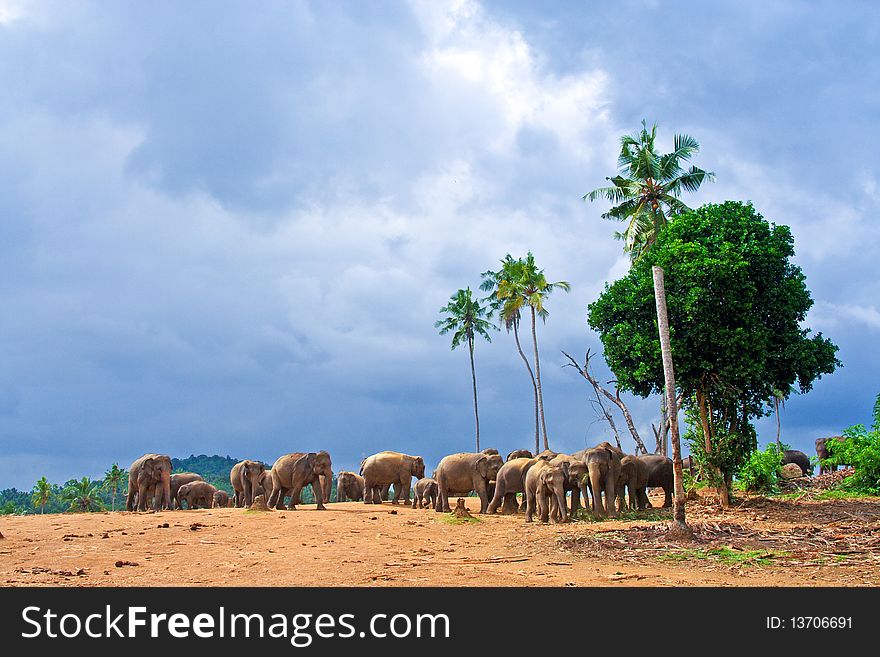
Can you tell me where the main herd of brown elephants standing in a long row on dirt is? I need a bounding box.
[126,442,672,522]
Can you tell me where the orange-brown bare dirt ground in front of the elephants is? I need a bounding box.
[0,490,880,586]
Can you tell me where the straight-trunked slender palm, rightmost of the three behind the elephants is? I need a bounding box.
[498,251,571,449]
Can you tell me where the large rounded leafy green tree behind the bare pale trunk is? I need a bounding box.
[588,201,840,501]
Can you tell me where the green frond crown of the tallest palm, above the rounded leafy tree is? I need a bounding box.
[584,120,715,260]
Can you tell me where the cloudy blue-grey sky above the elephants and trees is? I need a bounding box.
[0,0,880,488]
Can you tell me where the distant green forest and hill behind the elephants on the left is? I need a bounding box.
[0,454,336,515]
